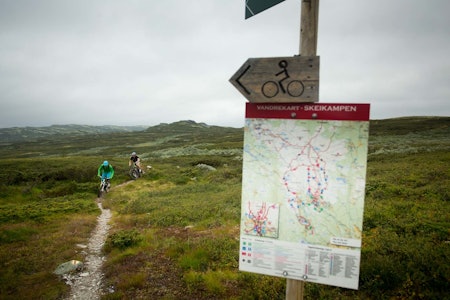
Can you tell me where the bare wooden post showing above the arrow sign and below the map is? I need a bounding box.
[286,0,319,300]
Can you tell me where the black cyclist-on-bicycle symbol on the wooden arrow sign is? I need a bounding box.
[261,60,305,98]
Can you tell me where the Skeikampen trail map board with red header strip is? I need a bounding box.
[239,103,370,289]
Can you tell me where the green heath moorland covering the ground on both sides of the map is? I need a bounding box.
[0,117,450,299]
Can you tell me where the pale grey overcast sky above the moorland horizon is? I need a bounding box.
[0,0,450,127]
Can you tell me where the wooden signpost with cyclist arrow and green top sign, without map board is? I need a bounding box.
[230,0,319,300]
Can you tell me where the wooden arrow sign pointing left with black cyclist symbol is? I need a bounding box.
[230,56,320,103]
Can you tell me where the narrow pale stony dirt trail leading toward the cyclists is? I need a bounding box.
[66,199,111,300]
